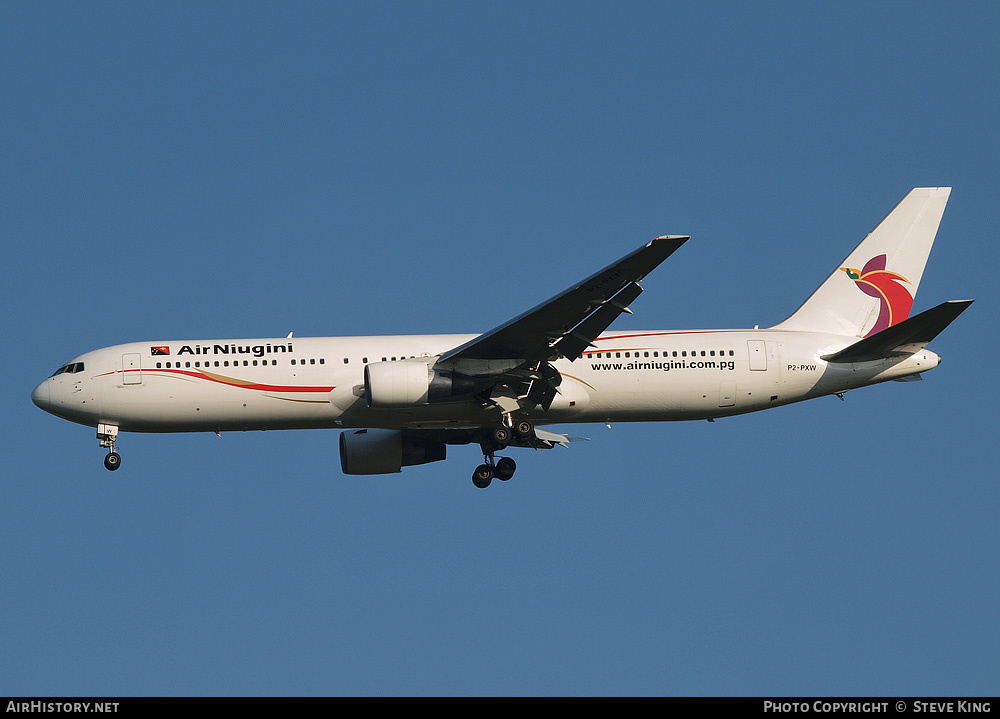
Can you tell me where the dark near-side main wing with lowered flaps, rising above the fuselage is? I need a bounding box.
[438,235,690,364]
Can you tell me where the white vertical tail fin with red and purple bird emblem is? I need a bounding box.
[774,187,951,337]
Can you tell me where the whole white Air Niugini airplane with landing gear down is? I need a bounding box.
[31,187,972,488]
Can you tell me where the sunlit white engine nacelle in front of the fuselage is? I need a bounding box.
[365,361,475,408]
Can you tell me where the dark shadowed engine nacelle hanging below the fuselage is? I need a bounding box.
[340,429,447,474]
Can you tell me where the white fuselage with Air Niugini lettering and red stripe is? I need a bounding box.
[32,330,940,432]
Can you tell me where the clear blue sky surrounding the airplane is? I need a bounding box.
[0,2,1000,696]
